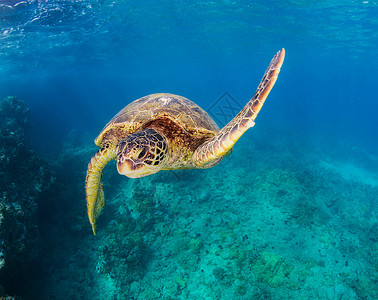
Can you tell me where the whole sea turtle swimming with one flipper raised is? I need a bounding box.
[85,49,285,234]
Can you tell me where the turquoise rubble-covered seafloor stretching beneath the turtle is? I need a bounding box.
[0,96,378,299]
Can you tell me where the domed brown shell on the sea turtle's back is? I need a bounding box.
[95,93,219,147]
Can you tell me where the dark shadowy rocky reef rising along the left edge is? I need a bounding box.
[0,97,54,299]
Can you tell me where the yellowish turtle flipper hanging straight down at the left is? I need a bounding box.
[85,145,115,235]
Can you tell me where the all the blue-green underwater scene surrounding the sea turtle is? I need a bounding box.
[0,0,378,299]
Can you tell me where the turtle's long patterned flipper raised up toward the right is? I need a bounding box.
[193,49,285,167]
